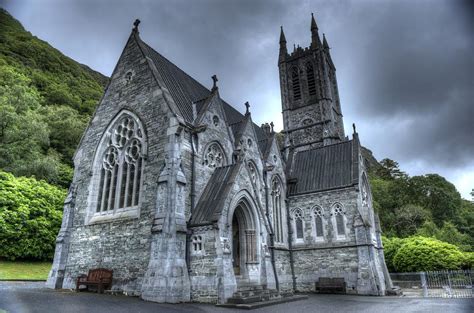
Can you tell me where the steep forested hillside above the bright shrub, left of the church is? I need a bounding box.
[0,8,108,187]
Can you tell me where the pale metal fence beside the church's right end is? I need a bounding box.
[390,270,474,298]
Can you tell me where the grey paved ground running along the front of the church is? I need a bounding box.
[0,282,474,313]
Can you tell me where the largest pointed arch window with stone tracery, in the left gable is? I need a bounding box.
[95,113,146,214]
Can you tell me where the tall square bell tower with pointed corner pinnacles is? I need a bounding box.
[278,14,345,155]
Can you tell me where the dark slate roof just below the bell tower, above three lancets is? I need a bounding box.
[288,140,358,195]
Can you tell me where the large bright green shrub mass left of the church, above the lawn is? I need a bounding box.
[0,171,66,260]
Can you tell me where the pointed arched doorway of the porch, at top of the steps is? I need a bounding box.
[232,200,259,283]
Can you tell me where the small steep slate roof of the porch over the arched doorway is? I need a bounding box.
[190,163,241,226]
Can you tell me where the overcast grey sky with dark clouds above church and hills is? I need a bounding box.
[0,0,474,199]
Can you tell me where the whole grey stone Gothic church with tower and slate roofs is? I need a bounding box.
[47,17,391,303]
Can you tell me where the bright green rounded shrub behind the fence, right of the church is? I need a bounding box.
[393,236,467,272]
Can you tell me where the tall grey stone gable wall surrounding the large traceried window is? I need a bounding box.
[54,33,168,294]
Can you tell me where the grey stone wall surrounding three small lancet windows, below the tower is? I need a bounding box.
[289,187,359,293]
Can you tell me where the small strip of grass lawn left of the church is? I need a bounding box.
[0,260,51,280]
